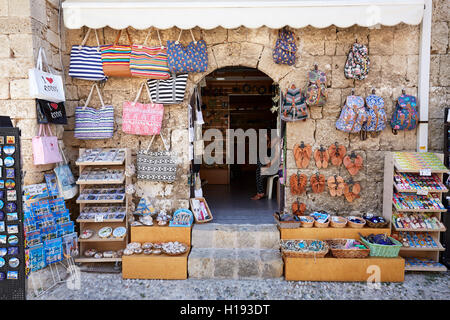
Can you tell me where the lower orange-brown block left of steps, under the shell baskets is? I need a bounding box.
[122,251,189,280]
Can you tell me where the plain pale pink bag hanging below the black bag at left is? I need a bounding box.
[32,124,62,165]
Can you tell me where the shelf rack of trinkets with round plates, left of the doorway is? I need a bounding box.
[75,148,131,263]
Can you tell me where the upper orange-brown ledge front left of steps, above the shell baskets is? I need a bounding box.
[131,225,192,247]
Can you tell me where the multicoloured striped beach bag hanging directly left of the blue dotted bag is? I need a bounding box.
[130,29,170,79]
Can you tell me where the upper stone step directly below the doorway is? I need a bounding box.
[192,223,280,249]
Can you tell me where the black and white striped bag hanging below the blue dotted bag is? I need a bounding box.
[147,73,188,104]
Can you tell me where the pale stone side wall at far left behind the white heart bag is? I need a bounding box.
[0,0,64,184]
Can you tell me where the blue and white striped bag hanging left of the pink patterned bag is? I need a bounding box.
[75,83,114,140]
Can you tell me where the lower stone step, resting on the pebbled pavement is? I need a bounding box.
[188,247,283,279]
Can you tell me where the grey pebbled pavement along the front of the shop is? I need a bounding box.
[28,272,450,300]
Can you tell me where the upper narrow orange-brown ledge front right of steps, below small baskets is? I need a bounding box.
[279,227,391,240]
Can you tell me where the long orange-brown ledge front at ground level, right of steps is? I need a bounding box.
[283,257,405,282]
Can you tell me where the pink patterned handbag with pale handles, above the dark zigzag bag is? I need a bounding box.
[122,82,164,135]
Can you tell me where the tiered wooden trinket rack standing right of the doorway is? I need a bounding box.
[383,152,449,271]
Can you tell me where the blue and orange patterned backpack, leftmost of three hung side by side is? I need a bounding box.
[336,95,367,133]
